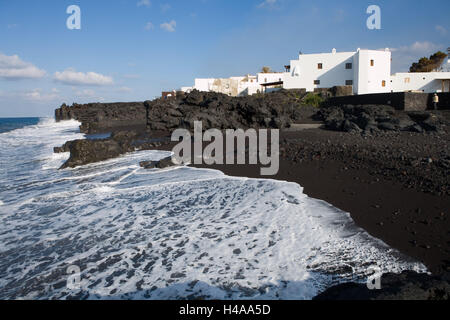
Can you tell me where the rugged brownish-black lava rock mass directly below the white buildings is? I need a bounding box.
[144,90,312,131]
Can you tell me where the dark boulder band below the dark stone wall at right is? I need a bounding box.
[317,105,447,133]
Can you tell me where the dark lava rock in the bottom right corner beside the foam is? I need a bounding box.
[314,271,450,300]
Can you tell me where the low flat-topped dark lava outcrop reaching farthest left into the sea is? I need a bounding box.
[55,102,146,133]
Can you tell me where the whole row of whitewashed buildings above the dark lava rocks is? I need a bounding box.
[181,49,450,96]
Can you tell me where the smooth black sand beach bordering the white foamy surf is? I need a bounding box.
[152,129,450,275]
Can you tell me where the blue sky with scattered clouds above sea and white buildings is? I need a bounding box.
[0,0,450,117]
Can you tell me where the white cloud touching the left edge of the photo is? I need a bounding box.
[0,52,46,80]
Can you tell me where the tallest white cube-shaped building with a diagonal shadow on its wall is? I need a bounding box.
[283,49,391,94]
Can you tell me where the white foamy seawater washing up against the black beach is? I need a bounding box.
[0,119,426,299]
